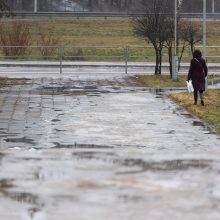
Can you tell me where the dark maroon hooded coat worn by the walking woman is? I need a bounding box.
[188,57,208,91]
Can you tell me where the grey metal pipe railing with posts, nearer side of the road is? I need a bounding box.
[0,45,220,73]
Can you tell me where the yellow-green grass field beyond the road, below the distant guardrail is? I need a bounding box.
[2,17,220,63]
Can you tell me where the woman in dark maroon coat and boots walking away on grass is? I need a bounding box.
[188,50,208,105]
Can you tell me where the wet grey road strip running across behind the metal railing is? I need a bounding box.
[0,61,220,78]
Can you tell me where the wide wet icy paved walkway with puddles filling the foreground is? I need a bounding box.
[0,76,220,220]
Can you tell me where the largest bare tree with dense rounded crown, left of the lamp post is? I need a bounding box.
[133,0,173,75]
